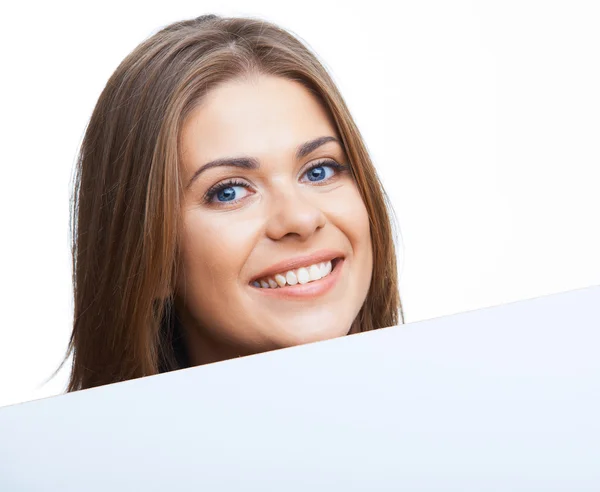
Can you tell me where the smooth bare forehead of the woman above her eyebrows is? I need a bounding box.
[182,76,337,164]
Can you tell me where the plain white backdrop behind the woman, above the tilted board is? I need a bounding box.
[0,0,600,406]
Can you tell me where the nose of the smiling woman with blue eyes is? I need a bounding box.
[267,187,326,240]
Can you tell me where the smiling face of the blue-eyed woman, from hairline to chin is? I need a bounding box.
[177,75,373,364]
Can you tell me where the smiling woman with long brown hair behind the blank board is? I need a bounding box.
[64,15,402,391]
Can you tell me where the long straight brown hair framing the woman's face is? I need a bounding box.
[67,15,404,391]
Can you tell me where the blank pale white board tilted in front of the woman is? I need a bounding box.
[0,287,600,492]
